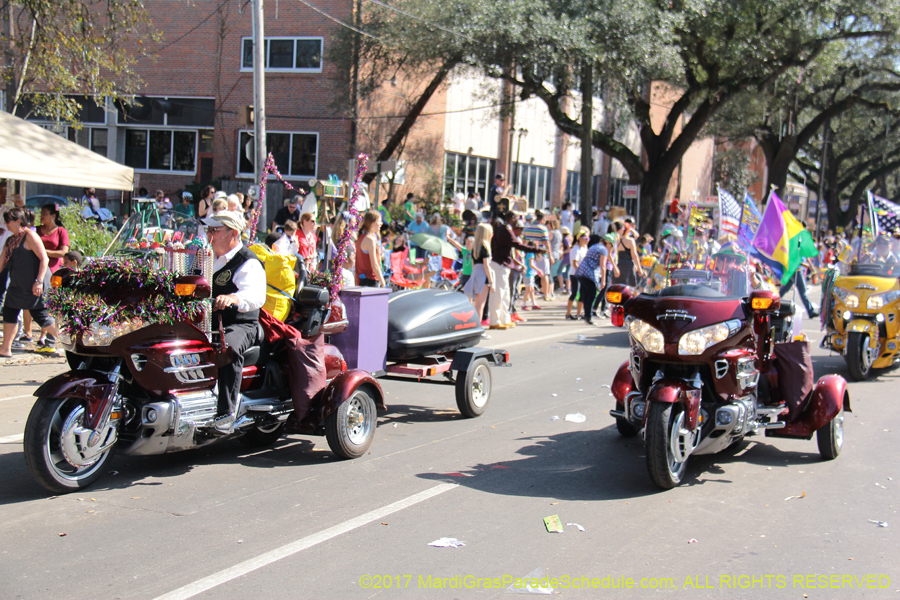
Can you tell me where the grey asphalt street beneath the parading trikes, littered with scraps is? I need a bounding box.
[0,290,900,600]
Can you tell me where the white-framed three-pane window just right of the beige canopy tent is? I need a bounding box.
[125,128,197,174]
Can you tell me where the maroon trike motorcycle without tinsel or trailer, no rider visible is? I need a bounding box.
[607,256,850,489]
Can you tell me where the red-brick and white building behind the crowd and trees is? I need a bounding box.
[10,0,709,221]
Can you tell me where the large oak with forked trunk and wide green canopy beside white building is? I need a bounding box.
[332,0,900,233]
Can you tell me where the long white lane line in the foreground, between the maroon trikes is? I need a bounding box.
[154,483,458,600]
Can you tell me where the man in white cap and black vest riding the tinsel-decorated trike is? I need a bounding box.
[203,212,266,435]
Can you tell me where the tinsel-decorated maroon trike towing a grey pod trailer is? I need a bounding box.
[24,237,509,493]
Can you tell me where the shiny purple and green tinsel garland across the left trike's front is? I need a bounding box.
[46,258,207,335]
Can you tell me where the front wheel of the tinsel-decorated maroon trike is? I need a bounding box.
[23,398,115,494]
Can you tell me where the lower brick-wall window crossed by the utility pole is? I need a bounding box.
[238,131,319,178]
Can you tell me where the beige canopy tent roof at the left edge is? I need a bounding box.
[0,112,134,191]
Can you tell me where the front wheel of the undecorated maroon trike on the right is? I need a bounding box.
[645,402,693,490]
